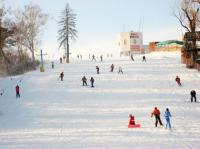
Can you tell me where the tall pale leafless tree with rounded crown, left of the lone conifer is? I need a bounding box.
[17,3,48,67]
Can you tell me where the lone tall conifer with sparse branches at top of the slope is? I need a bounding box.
[58,3,77,63]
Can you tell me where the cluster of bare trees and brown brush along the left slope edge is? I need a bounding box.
[0,3,48,76]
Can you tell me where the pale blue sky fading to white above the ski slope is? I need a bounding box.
[4,0,184,57]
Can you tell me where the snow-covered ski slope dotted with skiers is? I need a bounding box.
[0,52,200,149]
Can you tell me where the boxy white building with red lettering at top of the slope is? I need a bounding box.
[118,31,144,55]
